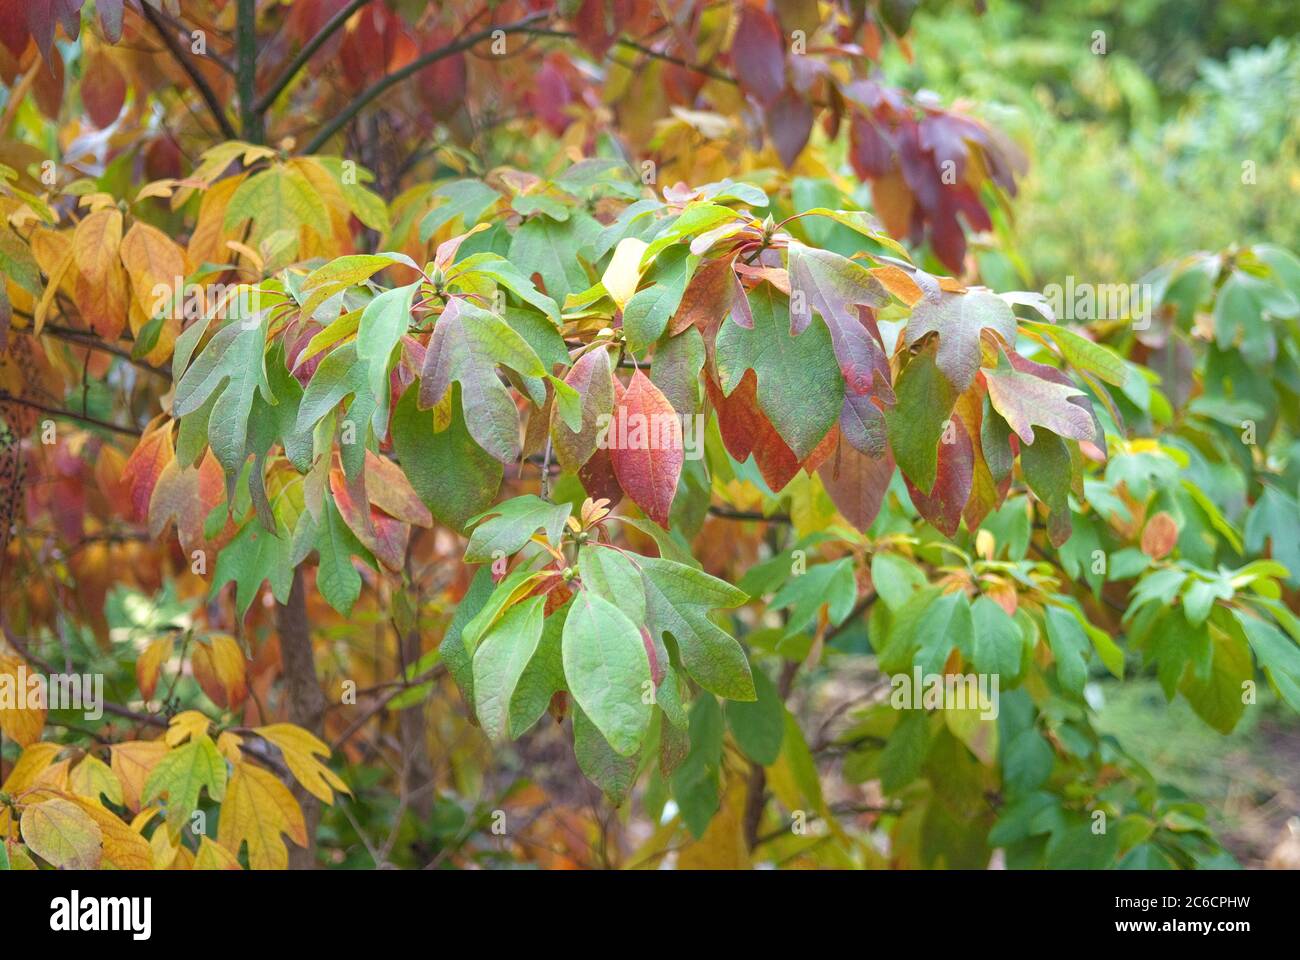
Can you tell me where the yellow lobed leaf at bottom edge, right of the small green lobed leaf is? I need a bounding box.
[217,762,307,870]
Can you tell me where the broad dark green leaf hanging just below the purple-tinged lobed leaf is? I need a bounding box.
[391,388,503,531]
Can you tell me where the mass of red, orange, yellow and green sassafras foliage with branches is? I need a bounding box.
[0,0,1300,869]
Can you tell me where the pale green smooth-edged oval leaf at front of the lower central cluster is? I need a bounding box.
[563,589,651,757]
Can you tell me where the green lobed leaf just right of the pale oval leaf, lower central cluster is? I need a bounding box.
[641,557,757,700]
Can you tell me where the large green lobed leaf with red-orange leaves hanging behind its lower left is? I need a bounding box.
[716,284,842,460]
